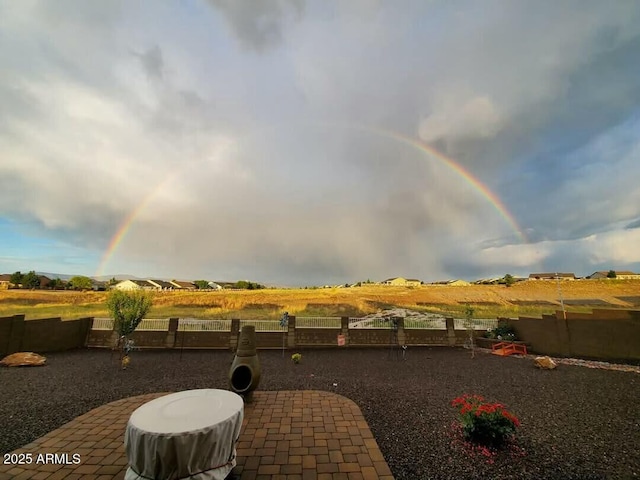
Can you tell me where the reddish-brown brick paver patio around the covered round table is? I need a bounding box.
[0,390,393,480]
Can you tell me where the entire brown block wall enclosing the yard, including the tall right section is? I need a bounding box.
[0,309,640,362]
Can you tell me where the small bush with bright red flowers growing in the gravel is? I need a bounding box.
[451,394,520,446]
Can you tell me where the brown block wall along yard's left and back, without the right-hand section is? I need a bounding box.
[0,315,464,355]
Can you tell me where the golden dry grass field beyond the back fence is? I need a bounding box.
[0,280,640,319]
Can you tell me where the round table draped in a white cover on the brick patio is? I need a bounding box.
[124,389,244,480]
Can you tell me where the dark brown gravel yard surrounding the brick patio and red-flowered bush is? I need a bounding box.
[0,348,640,480]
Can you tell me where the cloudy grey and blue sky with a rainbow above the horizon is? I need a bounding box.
[0,0,640,285]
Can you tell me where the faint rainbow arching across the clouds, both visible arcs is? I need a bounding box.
[95,123,529,276]
